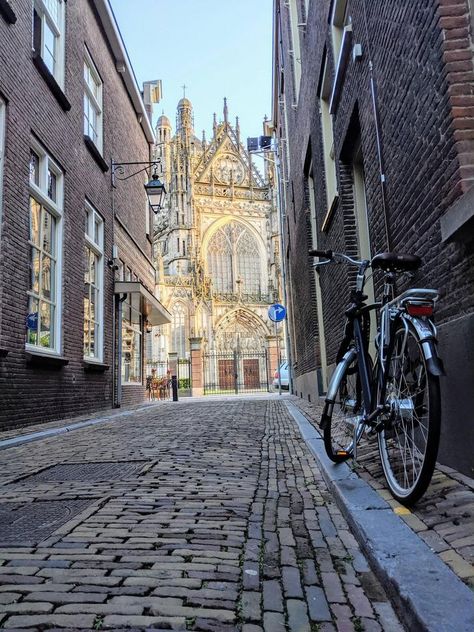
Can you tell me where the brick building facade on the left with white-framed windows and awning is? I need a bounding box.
[0,0,167,427]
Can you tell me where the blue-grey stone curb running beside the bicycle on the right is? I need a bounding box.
[285,402,474,632]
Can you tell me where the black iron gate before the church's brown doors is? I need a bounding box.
[203,350,269,395]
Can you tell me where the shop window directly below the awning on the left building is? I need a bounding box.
[122,293,142,384]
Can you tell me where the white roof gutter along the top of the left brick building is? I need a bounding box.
[93,0,155,143]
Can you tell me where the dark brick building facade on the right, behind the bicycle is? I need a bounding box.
[273,0,474,475]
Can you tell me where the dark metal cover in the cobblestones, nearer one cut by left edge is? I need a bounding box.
[0,499,93,546]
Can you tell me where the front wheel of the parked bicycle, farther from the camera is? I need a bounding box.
[322,355,364,463]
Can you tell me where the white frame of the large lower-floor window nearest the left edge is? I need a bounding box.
[25,139,64,355]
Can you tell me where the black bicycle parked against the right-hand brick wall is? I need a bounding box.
[309,250,444,505]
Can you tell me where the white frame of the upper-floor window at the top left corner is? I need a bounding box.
[34,0,66,89]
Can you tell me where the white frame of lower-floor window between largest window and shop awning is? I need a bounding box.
[84,200,104,362]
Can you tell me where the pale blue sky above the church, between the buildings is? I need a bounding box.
[110,0,272,144]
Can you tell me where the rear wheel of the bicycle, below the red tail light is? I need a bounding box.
[378,324,441,506]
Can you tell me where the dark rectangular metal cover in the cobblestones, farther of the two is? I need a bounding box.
[14,461,145,483]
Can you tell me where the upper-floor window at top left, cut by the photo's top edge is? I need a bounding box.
[33,0,65,88]
